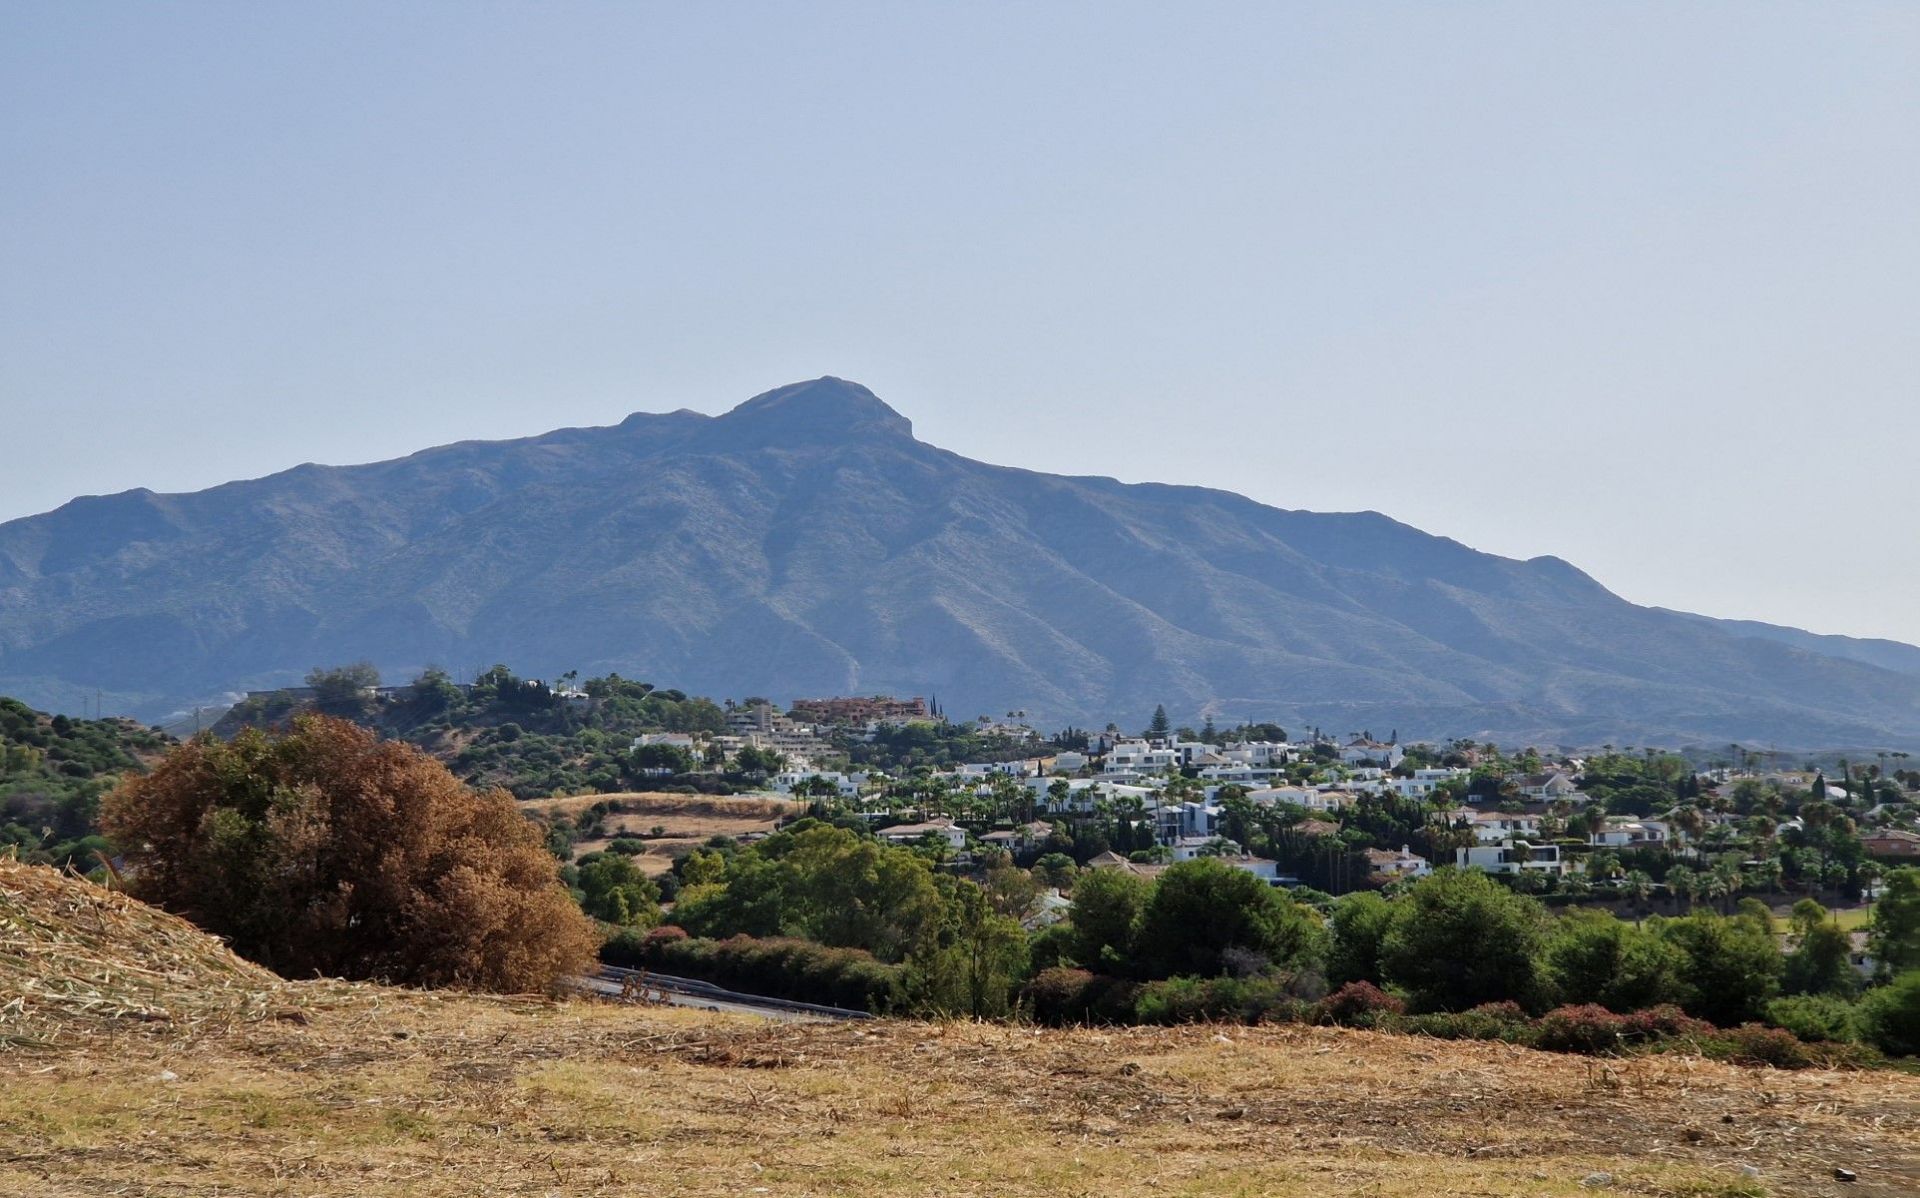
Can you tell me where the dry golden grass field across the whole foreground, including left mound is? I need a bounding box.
[0,862,1920,1198]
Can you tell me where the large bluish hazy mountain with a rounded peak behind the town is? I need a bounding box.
[0,378,1920,747]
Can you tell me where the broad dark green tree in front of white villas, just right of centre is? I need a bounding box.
[1135,858,1327,977]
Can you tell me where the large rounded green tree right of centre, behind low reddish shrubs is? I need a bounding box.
[1380,870,1546,1010]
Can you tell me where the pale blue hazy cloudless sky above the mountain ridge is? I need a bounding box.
[11,0,1920,641]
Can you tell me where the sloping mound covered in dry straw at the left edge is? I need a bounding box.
[0,858,288,1050]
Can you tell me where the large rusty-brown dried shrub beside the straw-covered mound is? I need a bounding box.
[100,716,597,991]
